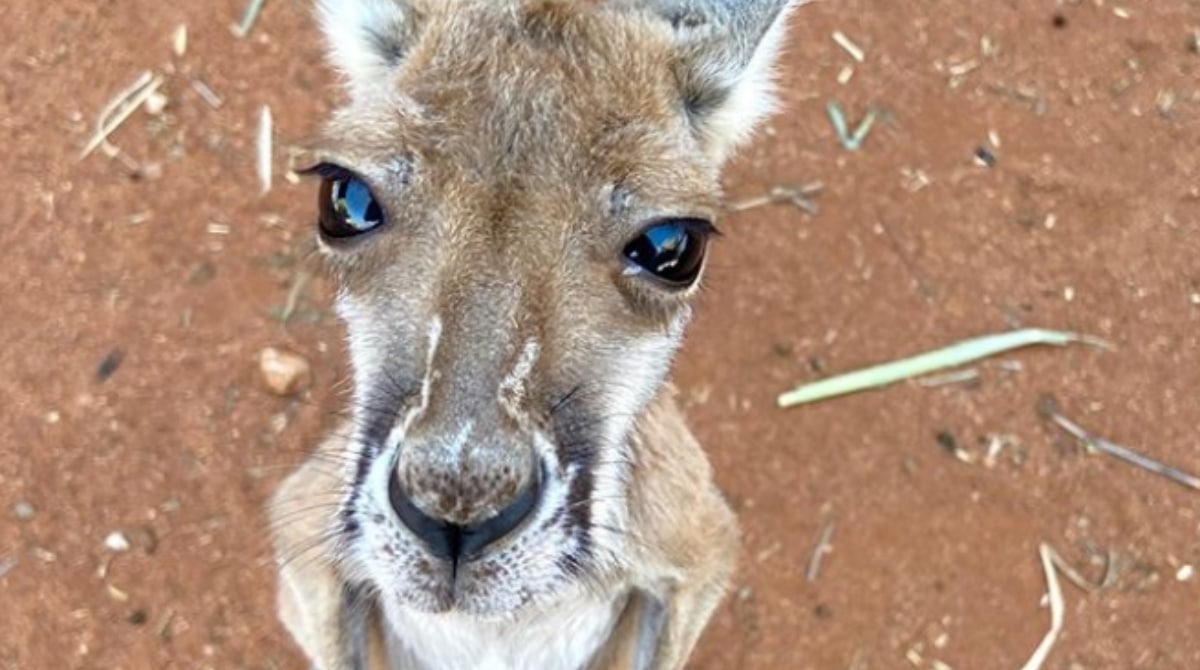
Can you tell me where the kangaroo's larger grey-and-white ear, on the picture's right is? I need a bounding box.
[620,0,809,160]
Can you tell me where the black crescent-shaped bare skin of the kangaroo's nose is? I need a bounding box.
[388,466,544,562]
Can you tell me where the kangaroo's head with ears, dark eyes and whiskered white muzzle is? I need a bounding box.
[312,0,794,616]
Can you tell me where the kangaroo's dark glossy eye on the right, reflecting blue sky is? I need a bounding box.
[624,219,715,287]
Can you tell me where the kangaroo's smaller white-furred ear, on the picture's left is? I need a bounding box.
[317,0,421,97]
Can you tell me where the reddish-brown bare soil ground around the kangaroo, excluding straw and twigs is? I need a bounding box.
[0,0,1200,670]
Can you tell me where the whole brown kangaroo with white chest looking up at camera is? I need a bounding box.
[271,0,802,670]
